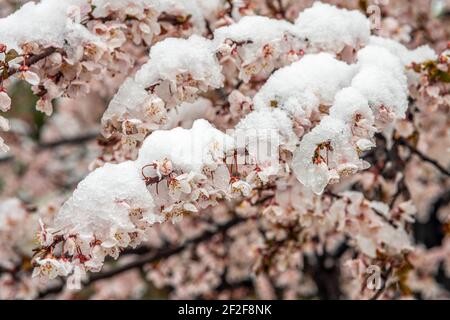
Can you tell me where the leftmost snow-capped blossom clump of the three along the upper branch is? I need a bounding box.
[102,36,223,141]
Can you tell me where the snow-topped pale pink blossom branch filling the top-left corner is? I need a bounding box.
[0,0,229,151]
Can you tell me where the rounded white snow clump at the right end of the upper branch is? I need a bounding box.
[295,2,370,54]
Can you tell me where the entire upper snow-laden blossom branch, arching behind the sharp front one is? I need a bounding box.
[102,3,370,146]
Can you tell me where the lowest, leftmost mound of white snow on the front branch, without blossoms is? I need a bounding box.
[55,161,160,240]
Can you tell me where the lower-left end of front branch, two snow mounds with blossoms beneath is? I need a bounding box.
[34,120,241,282]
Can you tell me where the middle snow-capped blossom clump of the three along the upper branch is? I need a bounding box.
[214,16,305,82]
